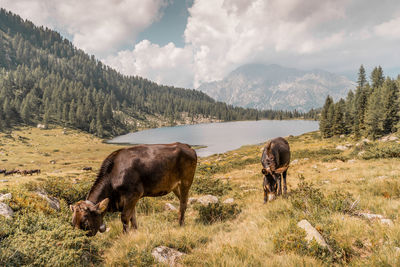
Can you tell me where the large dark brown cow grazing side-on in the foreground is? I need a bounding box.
[70,143,197,235]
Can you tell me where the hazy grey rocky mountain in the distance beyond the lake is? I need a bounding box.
[198,64,355,112]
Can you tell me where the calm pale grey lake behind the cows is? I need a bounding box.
[109,120,318,157]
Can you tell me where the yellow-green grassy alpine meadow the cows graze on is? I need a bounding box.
[0,128,400,266]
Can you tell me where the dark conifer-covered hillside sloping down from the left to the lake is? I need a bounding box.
[0,9,310,136]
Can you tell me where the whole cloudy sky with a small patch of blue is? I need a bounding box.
[0,0,400,88]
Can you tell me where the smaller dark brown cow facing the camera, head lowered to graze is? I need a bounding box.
[261,137,290,203]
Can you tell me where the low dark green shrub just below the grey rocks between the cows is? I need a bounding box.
[195,203,241,224]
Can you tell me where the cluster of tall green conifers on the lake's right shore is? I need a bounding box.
[319,65,400,139]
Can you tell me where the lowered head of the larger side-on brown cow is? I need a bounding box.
[70,198,109,236]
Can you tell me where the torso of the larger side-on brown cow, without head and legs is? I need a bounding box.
[111,143,197,196]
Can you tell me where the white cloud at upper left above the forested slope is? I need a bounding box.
[0,0,166,56]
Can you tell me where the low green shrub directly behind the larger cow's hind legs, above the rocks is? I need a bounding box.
[192,175,232,196]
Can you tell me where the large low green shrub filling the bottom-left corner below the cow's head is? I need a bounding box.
[0,212,101,266]
